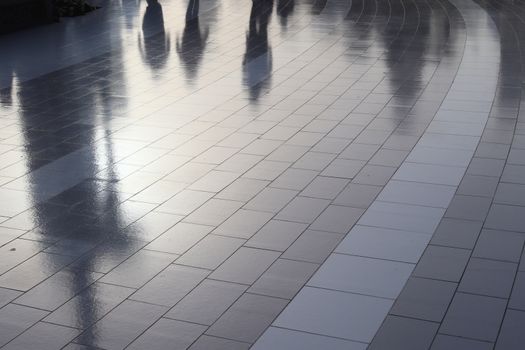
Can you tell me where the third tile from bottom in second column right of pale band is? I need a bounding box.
[458,258,518,298]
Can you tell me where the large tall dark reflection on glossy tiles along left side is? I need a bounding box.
[0,4,144,346]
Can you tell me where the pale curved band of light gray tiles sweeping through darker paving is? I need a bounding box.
[253,0,500,350]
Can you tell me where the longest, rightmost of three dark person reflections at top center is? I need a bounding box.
[242,0,273,100]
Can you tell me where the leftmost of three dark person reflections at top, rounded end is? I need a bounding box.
[139,0,170,72]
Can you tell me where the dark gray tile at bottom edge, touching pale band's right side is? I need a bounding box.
[368,316,439,350]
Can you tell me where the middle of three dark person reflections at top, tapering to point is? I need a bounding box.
[177,0,210,83]
